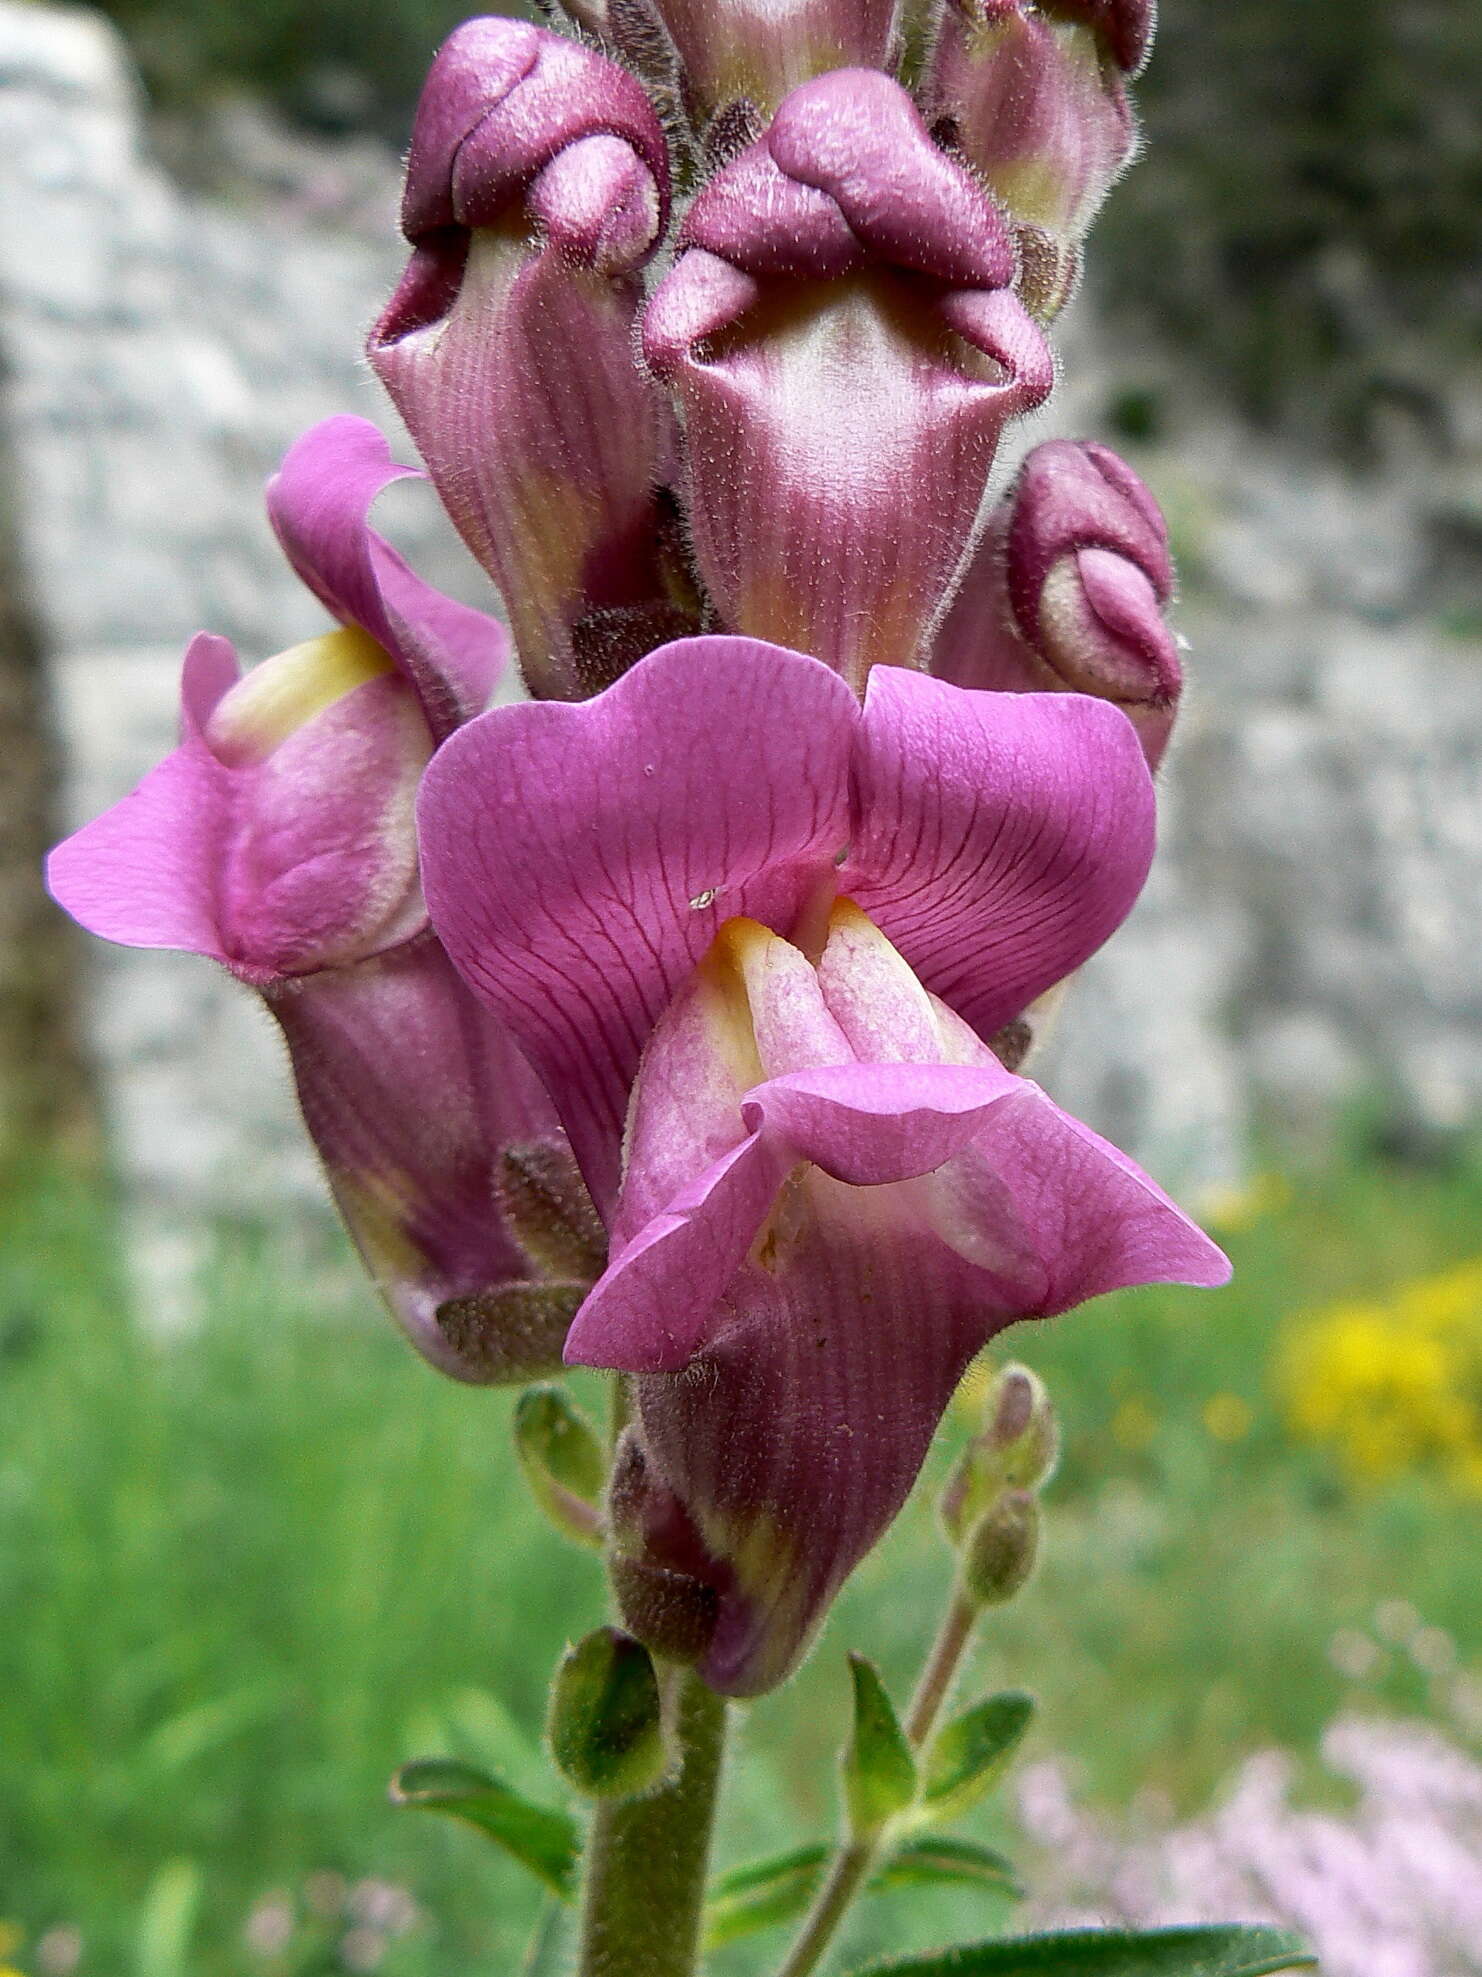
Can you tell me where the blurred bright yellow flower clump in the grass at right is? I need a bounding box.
[1276,1259,1482,1495]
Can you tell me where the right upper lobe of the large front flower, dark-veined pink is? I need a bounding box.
[840,666,1156,1040]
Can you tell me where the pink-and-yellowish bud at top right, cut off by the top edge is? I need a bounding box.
[923,0,1136,320]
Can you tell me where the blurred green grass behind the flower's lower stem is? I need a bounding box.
[0,1153,1482,1977]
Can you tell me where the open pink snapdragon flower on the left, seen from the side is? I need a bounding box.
[47,417,600,1380]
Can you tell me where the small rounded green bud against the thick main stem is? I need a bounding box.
[549,1627,668,1799]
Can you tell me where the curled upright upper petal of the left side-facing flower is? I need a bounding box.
[267,415,510,741]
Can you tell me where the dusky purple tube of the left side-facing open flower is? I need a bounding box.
[269,935,575,1382]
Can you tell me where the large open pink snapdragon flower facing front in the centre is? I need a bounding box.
[419,639,1227,1694]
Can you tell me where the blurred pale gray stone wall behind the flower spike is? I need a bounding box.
[0,0,1482,1281]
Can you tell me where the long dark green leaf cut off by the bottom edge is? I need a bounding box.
[858,1926,1318,1977]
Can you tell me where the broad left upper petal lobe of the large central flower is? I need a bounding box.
[419,639,860,1208]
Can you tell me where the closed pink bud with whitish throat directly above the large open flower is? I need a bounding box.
[644,69,1053,688]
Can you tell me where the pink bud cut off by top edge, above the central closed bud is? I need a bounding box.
[654,0,895,129]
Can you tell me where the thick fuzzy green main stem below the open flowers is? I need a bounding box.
[577,1671,725,1977]
